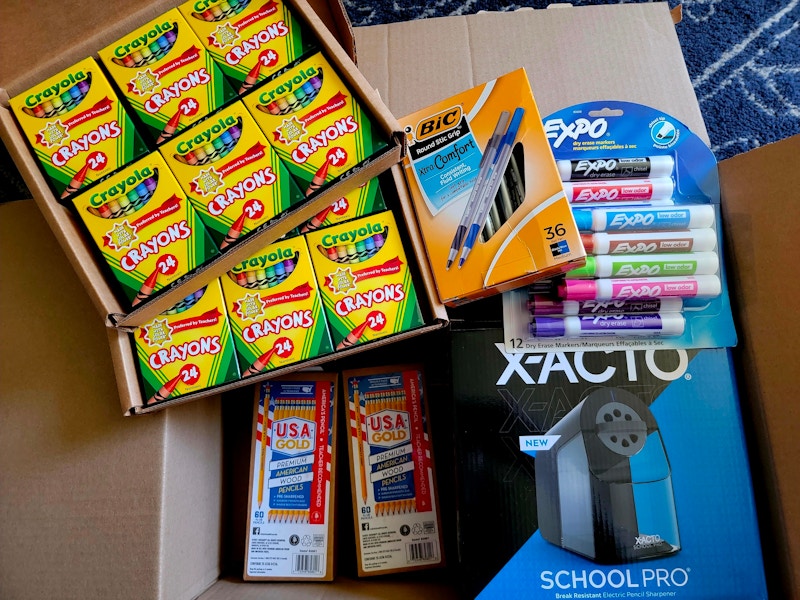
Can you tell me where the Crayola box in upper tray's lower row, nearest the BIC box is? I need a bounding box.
[242,52,388,196]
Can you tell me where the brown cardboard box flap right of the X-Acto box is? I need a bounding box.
[720,136,800,597]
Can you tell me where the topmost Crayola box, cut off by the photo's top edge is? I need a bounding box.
[178,0,317,94]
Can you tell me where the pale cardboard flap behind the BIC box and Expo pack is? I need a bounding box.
[355,2,708,143]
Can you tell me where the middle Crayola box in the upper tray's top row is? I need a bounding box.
[98,8,236,144]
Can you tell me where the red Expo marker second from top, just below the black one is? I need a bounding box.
[564,177,675,204]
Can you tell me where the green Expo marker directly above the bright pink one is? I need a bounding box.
[566,252,719,279]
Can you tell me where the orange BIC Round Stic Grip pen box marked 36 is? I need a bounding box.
[400,69,586,306]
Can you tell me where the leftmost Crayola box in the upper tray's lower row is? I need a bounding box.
[72,152,219,308]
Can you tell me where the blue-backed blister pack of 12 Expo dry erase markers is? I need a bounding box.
[503,102,736,352]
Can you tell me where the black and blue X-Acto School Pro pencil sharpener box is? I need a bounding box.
[452,328,767,600]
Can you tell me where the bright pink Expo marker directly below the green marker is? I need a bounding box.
[558,275,722,300]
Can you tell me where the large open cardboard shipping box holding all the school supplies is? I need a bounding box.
[0,1,800,600]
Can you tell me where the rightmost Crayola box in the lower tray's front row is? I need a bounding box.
[306,211,423,350]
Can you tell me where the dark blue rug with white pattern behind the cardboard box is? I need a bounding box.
[344,0,800,160]
